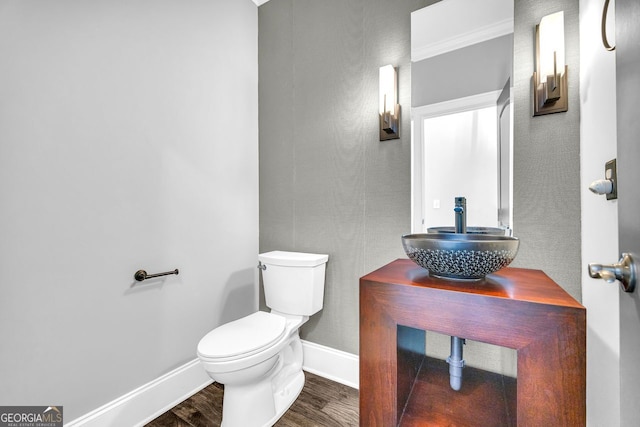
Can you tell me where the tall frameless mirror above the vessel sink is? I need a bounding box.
[411,0,514,234]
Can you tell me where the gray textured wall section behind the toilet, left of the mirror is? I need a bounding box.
[258,0,429,353]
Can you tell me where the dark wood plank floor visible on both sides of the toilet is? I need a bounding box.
[147,372,359,427]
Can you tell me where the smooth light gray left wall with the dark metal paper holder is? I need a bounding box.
[0,0,258,422]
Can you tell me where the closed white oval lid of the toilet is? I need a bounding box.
[198,311,286,358]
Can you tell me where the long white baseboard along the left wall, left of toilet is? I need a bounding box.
[65,359,213,427]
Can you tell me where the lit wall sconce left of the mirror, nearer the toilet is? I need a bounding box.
[380,65,400,141]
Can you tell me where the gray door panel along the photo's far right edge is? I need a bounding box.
[616,0,640,426]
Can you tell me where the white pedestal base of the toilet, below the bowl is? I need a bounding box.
[221,370,304,427]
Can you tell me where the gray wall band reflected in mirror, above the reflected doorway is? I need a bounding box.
[411,34,513,107]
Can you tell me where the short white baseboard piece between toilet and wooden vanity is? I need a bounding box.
[302,340,360,388]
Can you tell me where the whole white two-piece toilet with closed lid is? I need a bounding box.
[198,251,329,427]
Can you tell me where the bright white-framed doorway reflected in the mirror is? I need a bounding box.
[412,92,499,231]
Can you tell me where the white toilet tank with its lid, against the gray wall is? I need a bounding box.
[258,251,329,316]
